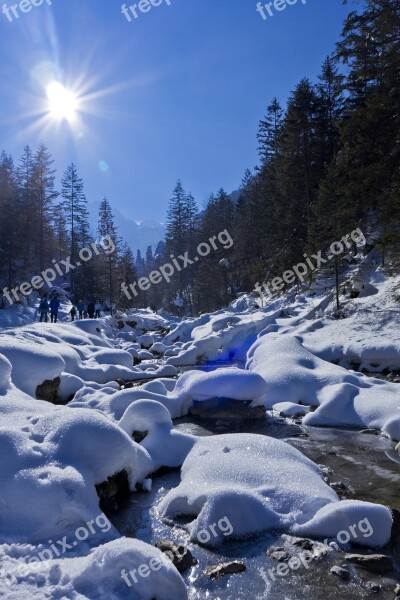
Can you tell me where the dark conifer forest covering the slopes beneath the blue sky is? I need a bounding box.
[0,0,400,314]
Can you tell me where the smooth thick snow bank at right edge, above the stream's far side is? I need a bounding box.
[247,333,400,440]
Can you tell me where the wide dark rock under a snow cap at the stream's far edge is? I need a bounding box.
[190,398,265,420]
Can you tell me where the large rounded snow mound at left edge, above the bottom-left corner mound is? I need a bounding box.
[0,390,138,542]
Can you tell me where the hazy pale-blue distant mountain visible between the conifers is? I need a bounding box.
[88,202,165,255]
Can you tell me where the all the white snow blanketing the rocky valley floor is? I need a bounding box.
[0,248,400,600]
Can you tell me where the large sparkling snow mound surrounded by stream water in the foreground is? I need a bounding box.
[157,434,392,547]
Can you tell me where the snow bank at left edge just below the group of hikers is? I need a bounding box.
[0,319,177,400]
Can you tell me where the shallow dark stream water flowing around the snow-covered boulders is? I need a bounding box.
[109,366,400,600]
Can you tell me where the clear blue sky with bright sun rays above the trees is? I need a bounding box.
[0,0,354,221]
